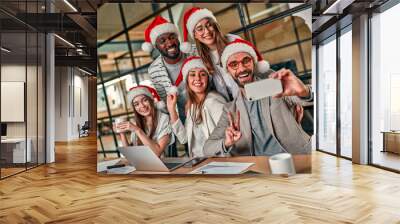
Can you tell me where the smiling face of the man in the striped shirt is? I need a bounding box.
[156,33,181,59]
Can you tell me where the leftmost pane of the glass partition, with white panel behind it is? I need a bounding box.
[0,32,27,177]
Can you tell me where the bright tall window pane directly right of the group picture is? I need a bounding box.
[317,36,337,154]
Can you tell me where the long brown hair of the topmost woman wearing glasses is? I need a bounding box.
[193,19,229,74]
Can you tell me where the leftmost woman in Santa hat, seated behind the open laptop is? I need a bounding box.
[116,85,174,157]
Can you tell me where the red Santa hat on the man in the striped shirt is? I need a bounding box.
[142,16,178,52]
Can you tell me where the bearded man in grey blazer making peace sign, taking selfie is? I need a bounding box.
[203,39,313,156]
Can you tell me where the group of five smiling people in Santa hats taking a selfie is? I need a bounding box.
[116,7,313,157]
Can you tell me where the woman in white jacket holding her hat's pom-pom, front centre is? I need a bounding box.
[167,56,226,157]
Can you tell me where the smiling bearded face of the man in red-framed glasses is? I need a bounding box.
[226,52,254,88]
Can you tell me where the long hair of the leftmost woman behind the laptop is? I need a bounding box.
[131,95,158,145]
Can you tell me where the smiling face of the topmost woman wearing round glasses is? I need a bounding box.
[193,18,215,46]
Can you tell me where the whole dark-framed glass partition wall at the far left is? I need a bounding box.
[0,1,46,179]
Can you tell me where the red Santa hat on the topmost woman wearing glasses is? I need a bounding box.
[180,7,217,53]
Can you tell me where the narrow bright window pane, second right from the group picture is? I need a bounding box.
[340,26,353,158]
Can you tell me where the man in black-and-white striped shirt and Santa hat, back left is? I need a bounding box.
[142,16,195,122]
